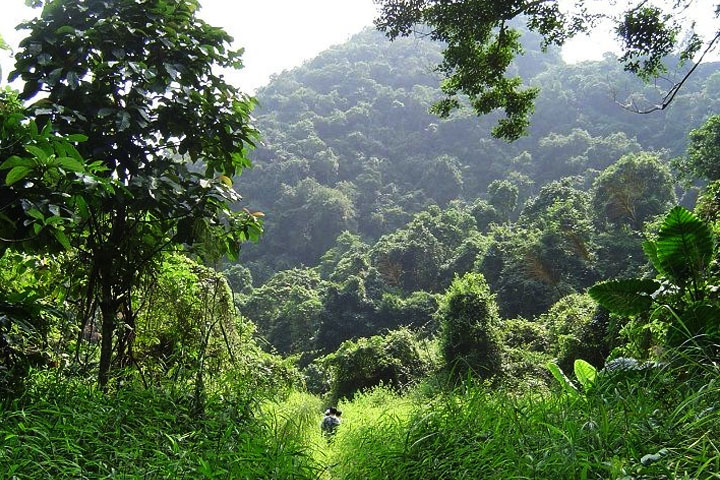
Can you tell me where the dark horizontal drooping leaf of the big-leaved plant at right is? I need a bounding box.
[588,279,660,315]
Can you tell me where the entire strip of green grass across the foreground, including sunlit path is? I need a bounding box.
[0,358,720,480]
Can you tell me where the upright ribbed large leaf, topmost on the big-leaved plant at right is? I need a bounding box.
[651,207,714,285]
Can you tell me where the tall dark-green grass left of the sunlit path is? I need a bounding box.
[0,377,318,480]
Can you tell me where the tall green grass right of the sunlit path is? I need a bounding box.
[333,354,720,480]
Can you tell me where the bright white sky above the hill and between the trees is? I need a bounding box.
[0,0,711,93]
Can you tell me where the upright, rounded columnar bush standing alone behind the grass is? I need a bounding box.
[438,273,501,377]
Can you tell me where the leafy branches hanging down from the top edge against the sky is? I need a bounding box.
[375,0,720,141]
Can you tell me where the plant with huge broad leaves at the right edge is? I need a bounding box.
[589,206,720,345]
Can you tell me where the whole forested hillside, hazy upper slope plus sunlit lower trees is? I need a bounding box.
[233,30,720,362]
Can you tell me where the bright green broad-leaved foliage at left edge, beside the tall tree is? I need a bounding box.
[0,89,107,255]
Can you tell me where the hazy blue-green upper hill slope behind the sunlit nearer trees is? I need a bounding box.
[238,30,720,281]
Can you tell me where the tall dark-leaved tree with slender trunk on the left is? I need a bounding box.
[11,0,261,385]
